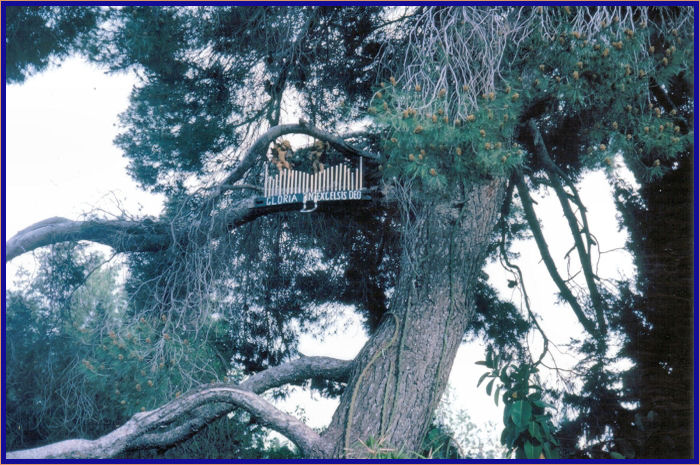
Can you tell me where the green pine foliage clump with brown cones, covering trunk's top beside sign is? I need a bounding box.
[368,80,525,189]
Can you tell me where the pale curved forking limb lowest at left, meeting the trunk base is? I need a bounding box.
[7,357,353,459]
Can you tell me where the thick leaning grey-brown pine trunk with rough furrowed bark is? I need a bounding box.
[323,179,505,458]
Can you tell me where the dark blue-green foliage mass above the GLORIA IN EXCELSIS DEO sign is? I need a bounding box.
[89,5,388,190]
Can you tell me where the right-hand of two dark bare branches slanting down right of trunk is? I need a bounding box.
[518,119,607,334]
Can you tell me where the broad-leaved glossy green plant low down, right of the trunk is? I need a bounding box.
[477,349,559,459]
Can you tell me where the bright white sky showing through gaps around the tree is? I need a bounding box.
[6,58,632,441]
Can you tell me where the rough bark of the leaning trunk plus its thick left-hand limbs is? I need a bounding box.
[6,125,505,459]
